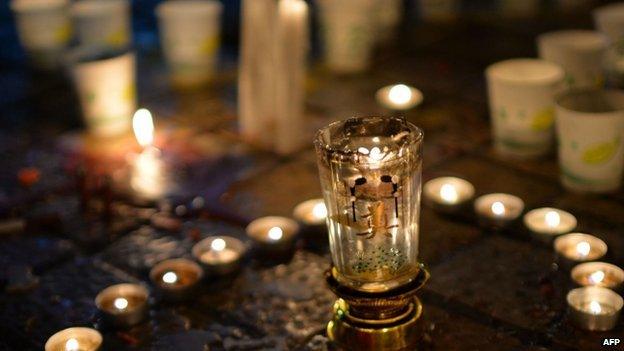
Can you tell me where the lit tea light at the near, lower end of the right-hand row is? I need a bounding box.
[567,286,624,331]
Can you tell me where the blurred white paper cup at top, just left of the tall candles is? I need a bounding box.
[156,0,223,87]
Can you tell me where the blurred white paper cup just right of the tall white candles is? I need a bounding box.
[318,0,377,73]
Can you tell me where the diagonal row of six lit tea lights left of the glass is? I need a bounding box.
[45,199,327,351]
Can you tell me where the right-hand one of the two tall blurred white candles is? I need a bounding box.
[275,0,309,154]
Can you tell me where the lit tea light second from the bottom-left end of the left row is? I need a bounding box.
[95,284,149,327]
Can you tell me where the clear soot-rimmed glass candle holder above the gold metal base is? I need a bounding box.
[315,117,423,292]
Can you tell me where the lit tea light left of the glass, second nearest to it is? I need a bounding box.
[246,216,299,253]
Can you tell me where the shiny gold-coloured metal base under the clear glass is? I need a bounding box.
[326,267,429,351]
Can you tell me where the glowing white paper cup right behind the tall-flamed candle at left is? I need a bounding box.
[70,48,137,137]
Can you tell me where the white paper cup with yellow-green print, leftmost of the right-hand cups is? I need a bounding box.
[485,59,564,157]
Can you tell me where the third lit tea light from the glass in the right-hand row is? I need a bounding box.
[524,207,576,238]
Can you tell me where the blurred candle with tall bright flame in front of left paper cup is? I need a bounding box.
[130,108,168,200]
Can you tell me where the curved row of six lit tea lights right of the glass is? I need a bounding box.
[423,177,624,330]
